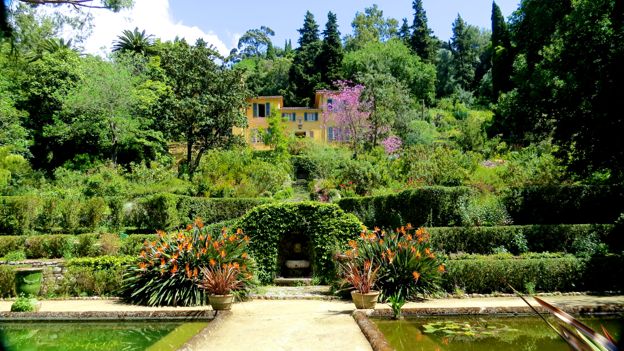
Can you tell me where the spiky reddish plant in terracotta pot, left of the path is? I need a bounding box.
[198,263,243,311]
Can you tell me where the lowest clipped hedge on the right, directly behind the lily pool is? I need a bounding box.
[442,254,624,293]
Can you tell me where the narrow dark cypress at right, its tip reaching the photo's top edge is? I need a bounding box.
[492,1,513,101]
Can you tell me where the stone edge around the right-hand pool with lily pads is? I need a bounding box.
[352,304,624,351]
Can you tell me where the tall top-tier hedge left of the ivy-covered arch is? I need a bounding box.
[0,193,271,235]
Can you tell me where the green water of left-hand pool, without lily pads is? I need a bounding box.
[0,321,208,351]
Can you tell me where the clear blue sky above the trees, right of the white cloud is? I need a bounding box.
[170,0,519,45]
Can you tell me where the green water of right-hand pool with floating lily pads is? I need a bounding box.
[373,316,624,351]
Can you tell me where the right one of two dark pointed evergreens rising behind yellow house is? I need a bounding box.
[317,11,344,88]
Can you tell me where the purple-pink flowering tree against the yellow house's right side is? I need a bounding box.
[324,81,370,155]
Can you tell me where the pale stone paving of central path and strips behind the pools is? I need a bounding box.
[0,286,624,351]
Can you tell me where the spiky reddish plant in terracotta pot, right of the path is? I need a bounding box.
[343,260,379,309]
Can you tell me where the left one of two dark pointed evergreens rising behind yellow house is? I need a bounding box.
[285,11,322,106]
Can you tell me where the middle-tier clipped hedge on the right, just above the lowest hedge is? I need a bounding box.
[428,224,622,255]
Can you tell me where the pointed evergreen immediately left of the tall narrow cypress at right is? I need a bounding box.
[451,14,476,90]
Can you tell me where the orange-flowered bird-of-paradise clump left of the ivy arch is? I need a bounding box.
[121,221,253,306]
